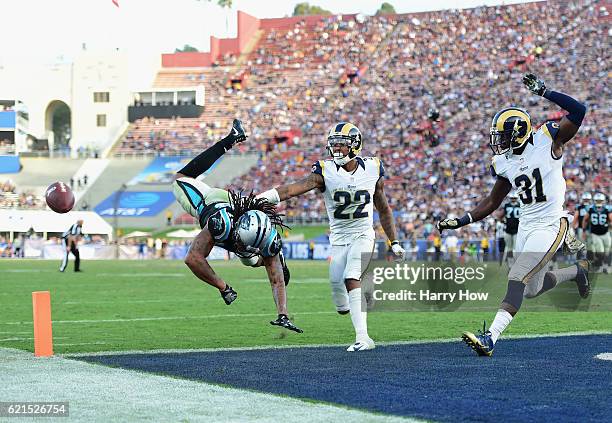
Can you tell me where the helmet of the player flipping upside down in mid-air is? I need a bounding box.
[234,210,281,258]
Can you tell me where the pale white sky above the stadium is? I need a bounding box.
[0,0,536,65]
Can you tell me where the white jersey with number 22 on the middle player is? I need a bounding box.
[312,157,385,245]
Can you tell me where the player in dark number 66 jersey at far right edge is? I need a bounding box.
[582,192,611,273]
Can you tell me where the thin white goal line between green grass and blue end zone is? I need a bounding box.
[61,331,612,357]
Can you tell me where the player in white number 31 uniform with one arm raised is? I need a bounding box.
[437,74,590,356]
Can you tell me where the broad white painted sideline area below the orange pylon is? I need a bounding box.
[0,348,422,423]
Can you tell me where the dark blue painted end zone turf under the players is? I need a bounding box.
[79,335,612,422]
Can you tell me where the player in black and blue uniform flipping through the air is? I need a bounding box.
[173,119,302,333]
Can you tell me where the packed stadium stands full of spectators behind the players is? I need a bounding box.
[113,1,612,239]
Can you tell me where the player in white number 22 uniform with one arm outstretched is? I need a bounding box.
[260,122,404,351]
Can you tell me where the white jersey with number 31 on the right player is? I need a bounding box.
[491,122,567,226]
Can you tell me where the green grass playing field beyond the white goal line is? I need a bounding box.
[0,260,612,353]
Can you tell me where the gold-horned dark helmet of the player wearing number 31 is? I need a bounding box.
[489,107,531,155]
